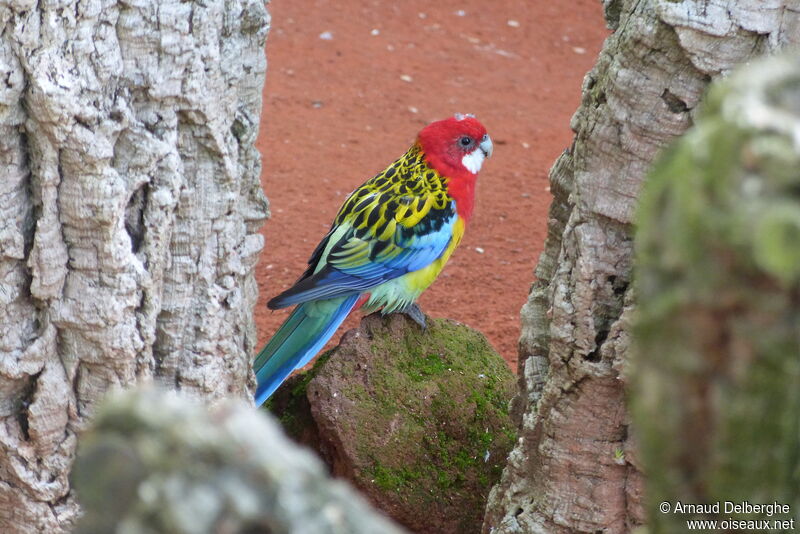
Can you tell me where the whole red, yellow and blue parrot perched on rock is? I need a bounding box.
[253,114,492,406]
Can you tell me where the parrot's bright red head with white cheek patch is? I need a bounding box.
[418,113,493,220]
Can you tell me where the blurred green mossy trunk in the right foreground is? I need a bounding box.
[630,56,800,533]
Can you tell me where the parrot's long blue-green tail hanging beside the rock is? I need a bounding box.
[253,294,359,406]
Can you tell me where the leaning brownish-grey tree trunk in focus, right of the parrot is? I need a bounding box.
[484,0,800,534]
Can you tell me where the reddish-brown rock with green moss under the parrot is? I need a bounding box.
[270,315,516,534]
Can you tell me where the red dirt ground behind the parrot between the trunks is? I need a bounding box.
[255,0,608,368]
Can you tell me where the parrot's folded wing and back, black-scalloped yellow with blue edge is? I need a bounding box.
[268,144,457,308]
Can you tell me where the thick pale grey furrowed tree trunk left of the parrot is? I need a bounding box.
[0,0,269,533]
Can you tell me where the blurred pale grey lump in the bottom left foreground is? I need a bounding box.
[73,390,410,534]
